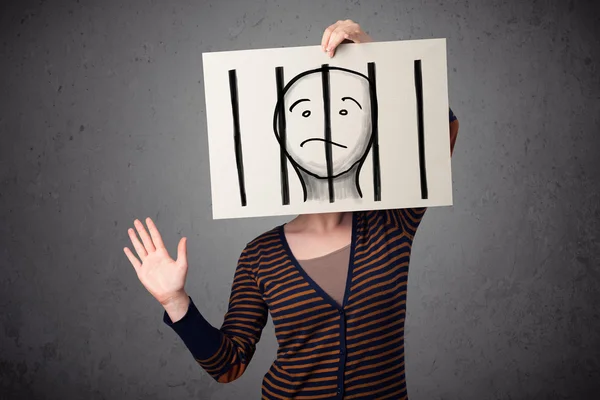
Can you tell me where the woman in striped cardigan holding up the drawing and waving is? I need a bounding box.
[124,20,458,399]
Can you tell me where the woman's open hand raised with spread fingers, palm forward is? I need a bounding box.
[123,218,188,306]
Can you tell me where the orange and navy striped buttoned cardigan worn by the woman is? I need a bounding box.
[163,208,426,399]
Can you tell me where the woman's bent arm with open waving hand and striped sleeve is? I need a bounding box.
[123,218,268,383]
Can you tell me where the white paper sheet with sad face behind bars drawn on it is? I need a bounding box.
[203,39,452,219]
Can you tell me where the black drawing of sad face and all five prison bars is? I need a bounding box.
[229,60,428,206]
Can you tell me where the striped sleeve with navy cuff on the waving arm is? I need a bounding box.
[163,250,268,383]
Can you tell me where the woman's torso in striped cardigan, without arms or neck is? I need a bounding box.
[256,211,412,399]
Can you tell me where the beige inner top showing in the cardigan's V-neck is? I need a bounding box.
[298,244,350,307]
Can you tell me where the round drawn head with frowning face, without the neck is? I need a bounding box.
[273,65,372,179]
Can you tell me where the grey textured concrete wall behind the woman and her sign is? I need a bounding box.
[0,0,600,400]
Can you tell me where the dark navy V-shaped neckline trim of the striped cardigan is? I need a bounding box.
[278,212,358,313]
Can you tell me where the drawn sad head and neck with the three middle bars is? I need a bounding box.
[273,63,379,204]
